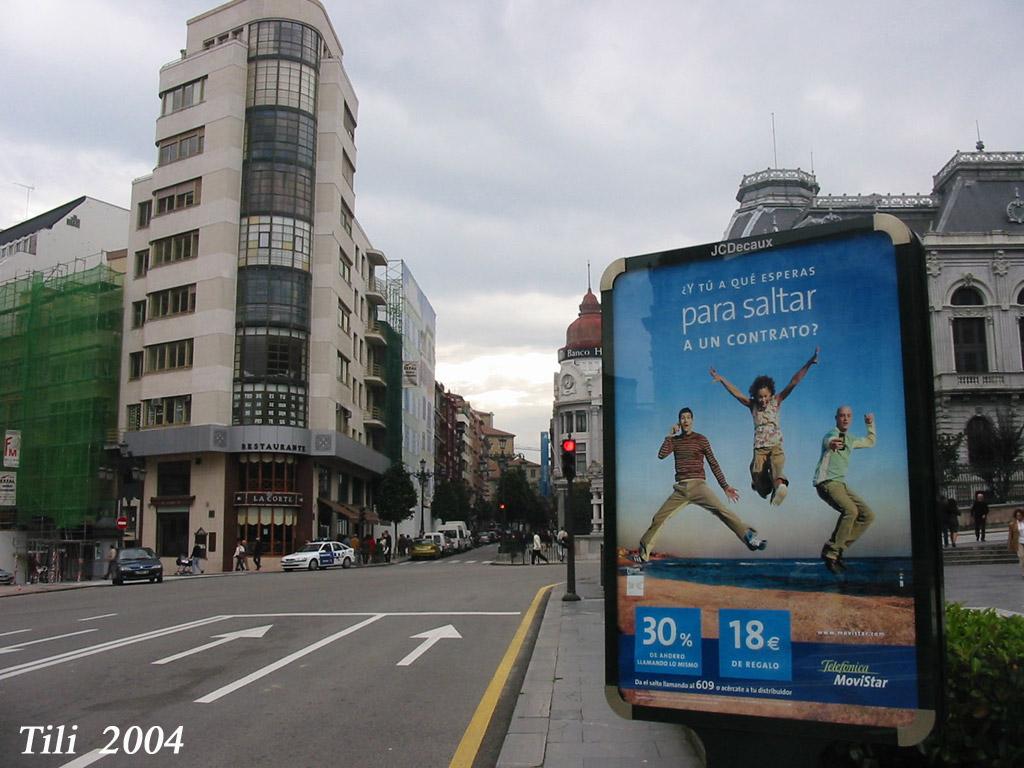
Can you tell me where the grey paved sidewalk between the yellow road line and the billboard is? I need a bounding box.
[498,561,703,768]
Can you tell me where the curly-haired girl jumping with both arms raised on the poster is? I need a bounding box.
[709,347,820,507]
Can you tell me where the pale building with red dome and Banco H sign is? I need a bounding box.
[551,286,604,540]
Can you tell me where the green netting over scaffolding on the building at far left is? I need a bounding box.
[0,261,123,532]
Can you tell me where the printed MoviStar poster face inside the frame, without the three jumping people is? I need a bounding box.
[606,232,918,726]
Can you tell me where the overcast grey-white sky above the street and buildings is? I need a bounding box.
[0,0,1024,459]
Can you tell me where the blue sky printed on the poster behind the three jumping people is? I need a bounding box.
[606,233,910,558]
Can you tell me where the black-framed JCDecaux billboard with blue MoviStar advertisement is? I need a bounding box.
[602,216,942,743]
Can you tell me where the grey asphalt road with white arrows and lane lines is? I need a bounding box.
[0,547,564,768]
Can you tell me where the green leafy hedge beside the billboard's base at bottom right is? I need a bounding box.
[823,606,1024,768]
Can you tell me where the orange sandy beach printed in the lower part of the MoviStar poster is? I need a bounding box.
[616,575,915,727]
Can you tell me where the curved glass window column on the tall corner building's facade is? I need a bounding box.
[232,20,322,427]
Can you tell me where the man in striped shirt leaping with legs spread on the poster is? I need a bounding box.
[633,408,768,564]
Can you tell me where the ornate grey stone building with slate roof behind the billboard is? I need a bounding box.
[725,149,1024,507]
